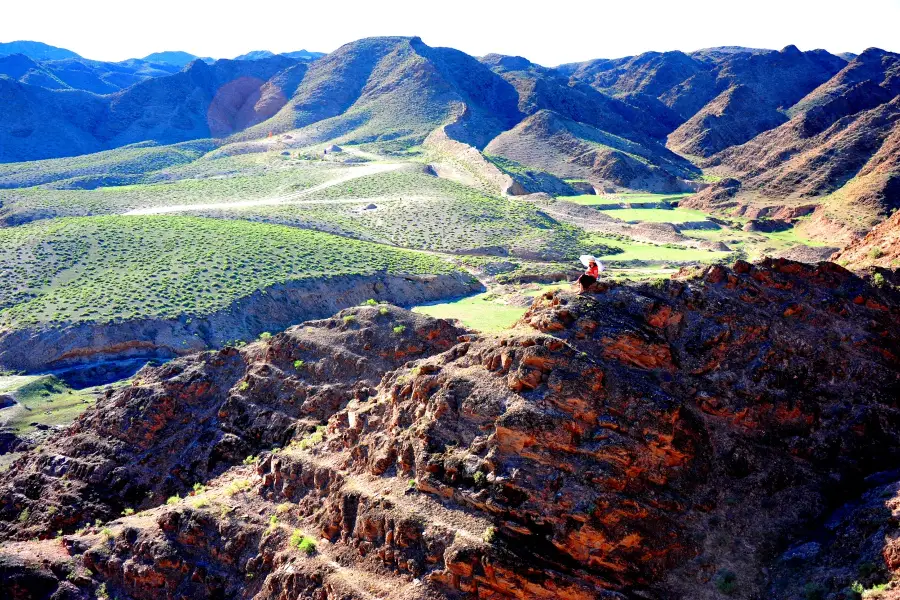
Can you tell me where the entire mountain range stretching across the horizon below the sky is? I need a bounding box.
[0,37,900,239]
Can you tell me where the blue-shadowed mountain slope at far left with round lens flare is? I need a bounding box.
[0,57,302,162]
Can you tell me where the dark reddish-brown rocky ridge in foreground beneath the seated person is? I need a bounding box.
[0,261,900,600]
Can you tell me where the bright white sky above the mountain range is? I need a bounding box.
[0,0,900,66]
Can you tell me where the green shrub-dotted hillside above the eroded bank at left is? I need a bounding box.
[0,217,460,327]
